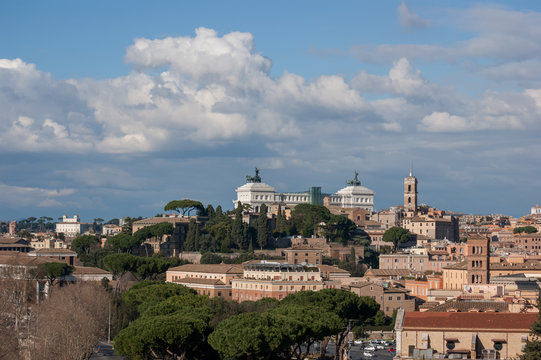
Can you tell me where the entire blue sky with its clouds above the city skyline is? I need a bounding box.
[0,1,541,220]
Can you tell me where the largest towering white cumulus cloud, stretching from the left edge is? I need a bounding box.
[0,28,380,153]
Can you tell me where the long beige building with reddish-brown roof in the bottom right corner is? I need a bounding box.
[395,310,537,359]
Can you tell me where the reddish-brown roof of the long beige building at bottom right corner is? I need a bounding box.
[404,312,537,333]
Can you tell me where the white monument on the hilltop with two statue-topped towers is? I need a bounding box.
[233,169,374,212]
